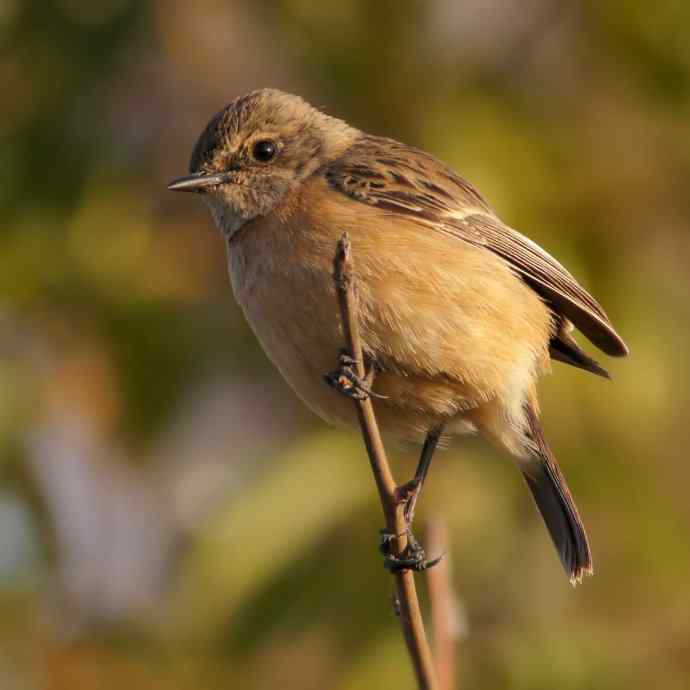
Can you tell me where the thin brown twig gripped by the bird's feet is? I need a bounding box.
[333,233,439,690]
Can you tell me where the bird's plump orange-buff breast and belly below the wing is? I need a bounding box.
[223,177,551,445]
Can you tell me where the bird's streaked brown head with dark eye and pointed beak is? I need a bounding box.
[168,89,359,235]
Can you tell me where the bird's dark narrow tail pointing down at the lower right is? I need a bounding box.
[522,406,592,584]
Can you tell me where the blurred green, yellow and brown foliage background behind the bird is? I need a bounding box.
[0,0,690,690]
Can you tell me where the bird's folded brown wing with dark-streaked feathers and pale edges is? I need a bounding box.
[323,136,628,357]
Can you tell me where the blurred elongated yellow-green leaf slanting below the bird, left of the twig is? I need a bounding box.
[167,432,375,634]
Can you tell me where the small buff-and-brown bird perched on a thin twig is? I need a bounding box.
[169,89,628,582]
